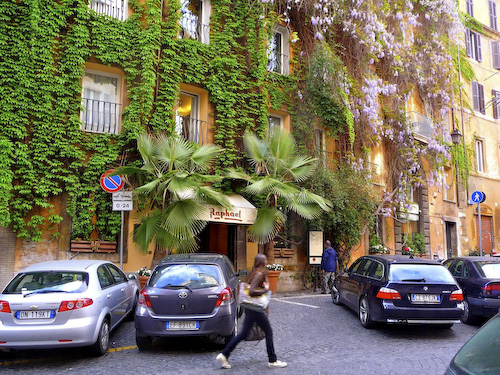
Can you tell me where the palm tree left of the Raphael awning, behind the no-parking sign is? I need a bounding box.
[114,134,230,259]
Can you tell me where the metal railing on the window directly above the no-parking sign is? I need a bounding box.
[81,98,121,134]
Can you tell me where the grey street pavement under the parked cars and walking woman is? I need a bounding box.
[0,293,478,375]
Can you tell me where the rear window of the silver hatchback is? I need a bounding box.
[3,271,89,294]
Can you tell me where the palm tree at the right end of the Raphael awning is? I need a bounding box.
[228,128,331,262]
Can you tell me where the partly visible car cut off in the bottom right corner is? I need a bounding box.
[445,314,500,375]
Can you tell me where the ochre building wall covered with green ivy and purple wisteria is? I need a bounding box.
[0,0,474,288]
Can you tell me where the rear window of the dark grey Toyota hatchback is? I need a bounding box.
[149,264,222,290]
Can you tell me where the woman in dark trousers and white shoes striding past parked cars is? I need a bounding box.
[217,254,287,368]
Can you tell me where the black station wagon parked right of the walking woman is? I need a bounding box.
[332,255,463,328]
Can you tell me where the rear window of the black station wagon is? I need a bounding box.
[389,263,455,284]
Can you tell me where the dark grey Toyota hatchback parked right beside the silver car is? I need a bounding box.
[135,253,239,350]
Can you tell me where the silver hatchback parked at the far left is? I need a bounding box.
[0,260,139,355]
